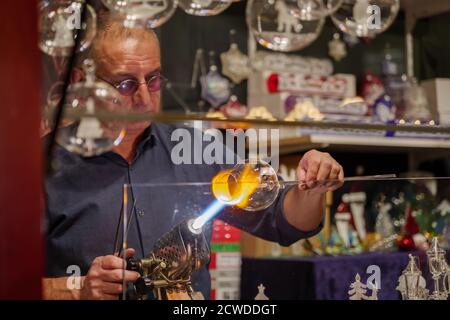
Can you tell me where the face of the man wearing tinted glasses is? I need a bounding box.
[95,35,161,134]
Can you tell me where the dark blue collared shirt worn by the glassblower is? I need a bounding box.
[45,123,320,298]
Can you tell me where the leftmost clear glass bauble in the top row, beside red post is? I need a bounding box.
[39,0,97,57]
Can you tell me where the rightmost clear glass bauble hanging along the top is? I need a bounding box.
[331,0,400,38]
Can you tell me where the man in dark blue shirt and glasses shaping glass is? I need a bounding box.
[43,16,343,299]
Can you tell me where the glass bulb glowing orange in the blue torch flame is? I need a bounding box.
[212,160,280,211]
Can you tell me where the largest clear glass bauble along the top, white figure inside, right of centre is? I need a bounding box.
[246,0,325,52]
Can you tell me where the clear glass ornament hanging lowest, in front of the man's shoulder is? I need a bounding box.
[57,59,125,157]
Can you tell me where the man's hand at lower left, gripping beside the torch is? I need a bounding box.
[80,249,140,300]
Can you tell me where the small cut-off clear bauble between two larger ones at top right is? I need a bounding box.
[294,0,343,21]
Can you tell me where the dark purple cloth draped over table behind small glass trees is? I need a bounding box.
[241,252,426,300]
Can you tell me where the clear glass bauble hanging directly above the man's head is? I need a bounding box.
[102,0,178,28]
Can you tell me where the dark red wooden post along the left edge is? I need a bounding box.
[0,0,44,299]
